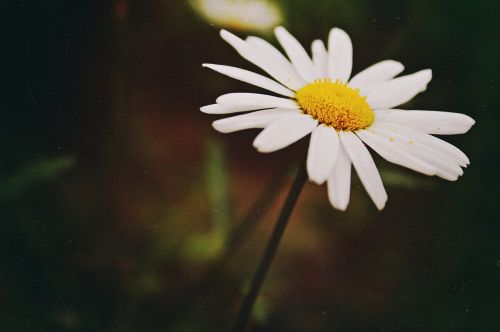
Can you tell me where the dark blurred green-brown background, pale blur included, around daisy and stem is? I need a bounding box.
[0,0,500,331]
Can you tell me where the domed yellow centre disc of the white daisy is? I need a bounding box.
[296,78,375,131]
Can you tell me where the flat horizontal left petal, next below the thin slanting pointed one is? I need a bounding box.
[216,93,299,109]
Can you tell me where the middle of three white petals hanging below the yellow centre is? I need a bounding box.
[327,145,351,211]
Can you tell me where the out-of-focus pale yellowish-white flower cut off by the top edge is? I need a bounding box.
[191,0,283,31]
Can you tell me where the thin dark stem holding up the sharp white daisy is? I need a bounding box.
[233,162,307,331]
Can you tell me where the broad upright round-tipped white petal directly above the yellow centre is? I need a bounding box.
[328,28,352,82]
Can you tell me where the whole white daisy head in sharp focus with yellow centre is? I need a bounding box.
[201,27,474,210]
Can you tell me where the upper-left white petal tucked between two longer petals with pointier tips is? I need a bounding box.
[246,36,307,90]
